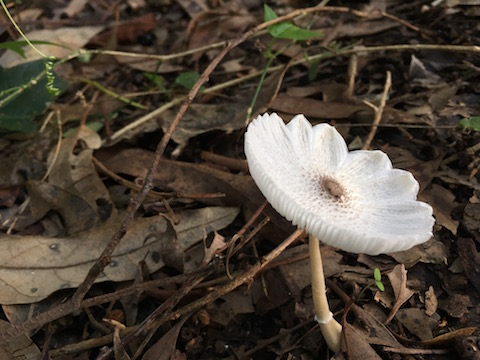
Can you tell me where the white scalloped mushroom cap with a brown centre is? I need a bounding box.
[245,113,435,255]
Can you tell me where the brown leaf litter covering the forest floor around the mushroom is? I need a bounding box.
[0,0,480,359]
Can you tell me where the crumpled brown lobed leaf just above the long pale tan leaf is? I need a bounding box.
[27,126,117,234]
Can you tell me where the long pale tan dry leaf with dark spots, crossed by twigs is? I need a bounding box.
[0,207,239,304]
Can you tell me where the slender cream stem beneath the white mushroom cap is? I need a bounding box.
[309,235,342,353]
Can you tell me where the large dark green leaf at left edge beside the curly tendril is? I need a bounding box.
[0,59,68,132]
